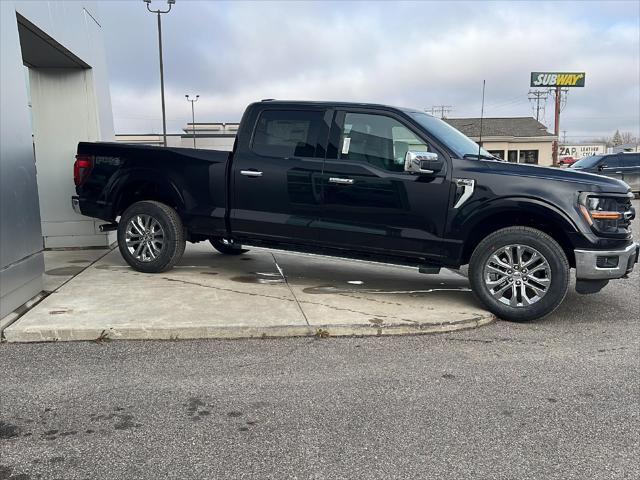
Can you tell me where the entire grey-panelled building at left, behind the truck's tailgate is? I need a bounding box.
[0,0,113,318]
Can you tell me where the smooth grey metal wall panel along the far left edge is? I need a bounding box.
[0,2,44,317]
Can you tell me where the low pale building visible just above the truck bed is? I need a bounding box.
[115,122,240,151]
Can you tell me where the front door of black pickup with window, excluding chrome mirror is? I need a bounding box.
[320,109,451,257]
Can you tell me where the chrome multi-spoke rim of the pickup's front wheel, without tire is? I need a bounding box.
[483,244,551,307]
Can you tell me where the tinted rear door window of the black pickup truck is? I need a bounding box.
[252,110,324,158]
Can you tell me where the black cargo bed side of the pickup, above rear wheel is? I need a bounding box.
[77,142,231,235]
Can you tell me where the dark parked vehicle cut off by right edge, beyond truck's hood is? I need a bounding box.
[571,152,640,195]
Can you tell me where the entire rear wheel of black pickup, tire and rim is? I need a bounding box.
[118,200,185,273]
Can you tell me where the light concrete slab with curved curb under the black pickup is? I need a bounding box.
[4,243,493,342]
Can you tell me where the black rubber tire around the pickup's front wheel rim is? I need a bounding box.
[469,227,570,322]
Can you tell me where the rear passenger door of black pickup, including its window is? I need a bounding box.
[230,106,329,243]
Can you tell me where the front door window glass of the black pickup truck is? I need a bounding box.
[340,113,429,172]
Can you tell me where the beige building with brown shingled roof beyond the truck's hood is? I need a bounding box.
[444,117,557,165]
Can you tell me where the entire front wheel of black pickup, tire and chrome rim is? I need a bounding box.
[469,227,569,321]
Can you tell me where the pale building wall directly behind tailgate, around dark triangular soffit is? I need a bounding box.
[16,1,115,248]
